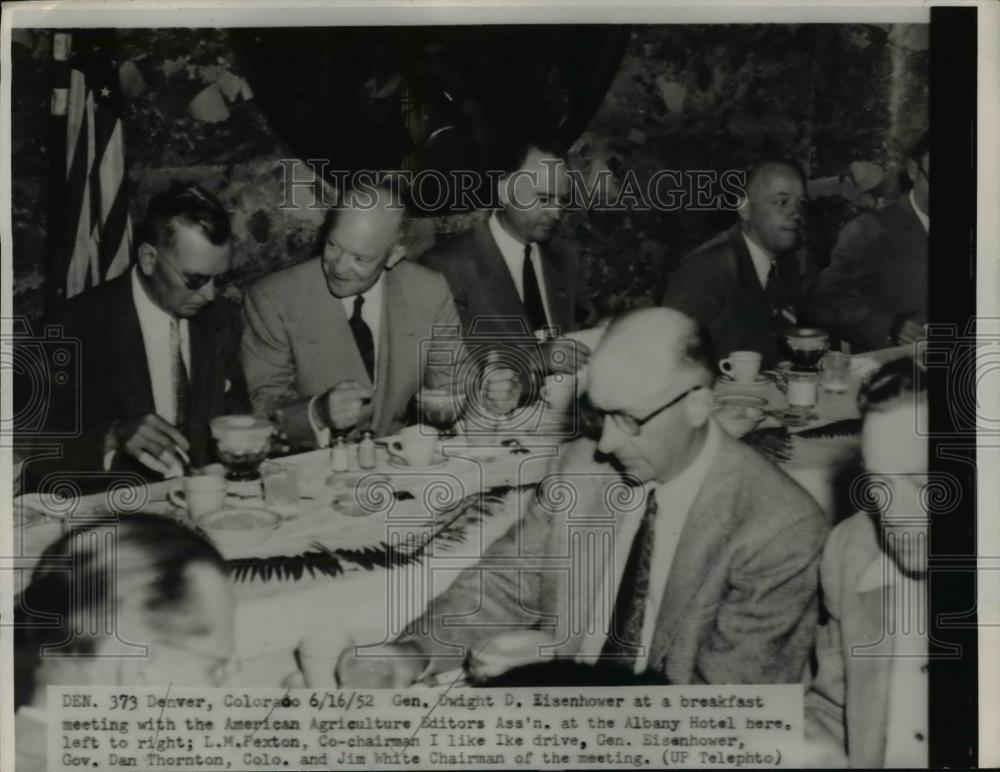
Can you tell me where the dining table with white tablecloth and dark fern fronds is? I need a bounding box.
[13,347,911,687]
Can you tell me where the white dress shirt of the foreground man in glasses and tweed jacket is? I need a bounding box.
[580,420,722,673]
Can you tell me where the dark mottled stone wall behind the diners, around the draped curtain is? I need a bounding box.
[11,24,928,319]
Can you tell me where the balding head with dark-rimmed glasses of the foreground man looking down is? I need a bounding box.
[588,308,713,481]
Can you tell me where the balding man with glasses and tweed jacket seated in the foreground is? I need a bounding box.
[339,308,827,686]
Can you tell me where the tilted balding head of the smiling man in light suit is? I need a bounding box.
[321,187,405,298]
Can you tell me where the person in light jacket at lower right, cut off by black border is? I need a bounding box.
[805,358,932,769]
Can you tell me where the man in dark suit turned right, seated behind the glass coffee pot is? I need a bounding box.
[663,158,806,366]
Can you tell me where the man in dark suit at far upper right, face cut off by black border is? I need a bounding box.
[811,133,931,351]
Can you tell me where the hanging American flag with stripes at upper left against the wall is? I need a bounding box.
[48,30,132,299]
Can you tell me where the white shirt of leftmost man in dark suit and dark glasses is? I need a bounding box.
[132,266,191,424]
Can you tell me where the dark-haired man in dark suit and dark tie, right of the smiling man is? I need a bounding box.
[421,140,594,372]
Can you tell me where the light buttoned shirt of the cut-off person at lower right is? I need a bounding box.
[855,553,929,769]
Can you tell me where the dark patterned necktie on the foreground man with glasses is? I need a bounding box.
[600,491,657,667]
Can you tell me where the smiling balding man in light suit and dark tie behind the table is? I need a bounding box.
[242,183,459,448]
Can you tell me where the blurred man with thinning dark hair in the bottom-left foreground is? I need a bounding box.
[14,514,235,772]
